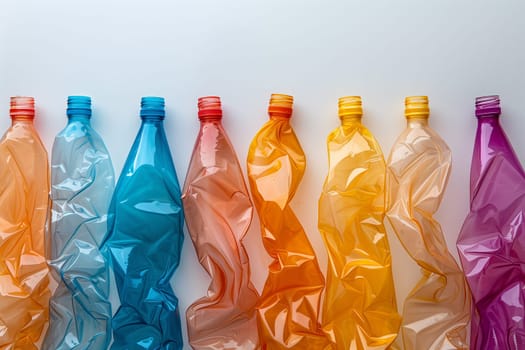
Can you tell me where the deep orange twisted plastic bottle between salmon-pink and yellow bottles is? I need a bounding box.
[248,94,328,350]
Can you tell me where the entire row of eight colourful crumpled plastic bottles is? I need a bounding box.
[0,94,525,350]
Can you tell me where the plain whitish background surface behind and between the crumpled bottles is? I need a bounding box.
[0,0,525,348]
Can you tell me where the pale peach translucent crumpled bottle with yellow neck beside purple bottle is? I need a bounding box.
[387,96,470,350]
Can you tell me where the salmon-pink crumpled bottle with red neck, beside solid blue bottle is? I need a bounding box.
[182,96,259,350]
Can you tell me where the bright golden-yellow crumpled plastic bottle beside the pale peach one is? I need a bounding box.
[319,96,400,350]
